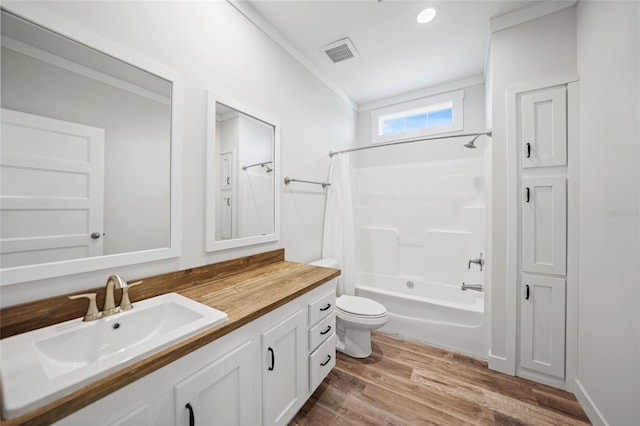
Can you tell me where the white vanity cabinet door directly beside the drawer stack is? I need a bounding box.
[262,309,309,425]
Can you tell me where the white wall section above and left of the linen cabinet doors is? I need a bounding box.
[487,8,576,366]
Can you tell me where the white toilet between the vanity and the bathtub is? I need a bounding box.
[311,259,389,358]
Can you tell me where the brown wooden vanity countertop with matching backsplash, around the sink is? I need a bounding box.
[0,250,340,426]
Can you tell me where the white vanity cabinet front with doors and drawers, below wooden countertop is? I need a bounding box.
[57,279,336,426]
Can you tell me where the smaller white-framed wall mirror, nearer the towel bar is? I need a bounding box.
[206,91,280,251]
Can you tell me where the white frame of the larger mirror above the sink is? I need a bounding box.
[0,2,184,286]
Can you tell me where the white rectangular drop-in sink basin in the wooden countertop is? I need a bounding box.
[0,293,228,419]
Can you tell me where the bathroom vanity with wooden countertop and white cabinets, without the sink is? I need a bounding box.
[2,250,339,425]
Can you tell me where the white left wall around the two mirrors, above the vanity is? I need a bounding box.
[0,1,356,306]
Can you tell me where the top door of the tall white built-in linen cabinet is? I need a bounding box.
[521,86,567,168]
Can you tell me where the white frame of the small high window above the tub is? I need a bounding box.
[371,90,464,145]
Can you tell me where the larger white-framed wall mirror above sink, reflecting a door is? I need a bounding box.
[0,6,180,285]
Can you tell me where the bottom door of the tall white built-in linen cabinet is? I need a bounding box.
[520,274,565,378]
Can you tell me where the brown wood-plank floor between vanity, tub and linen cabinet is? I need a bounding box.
[291,333,589,426]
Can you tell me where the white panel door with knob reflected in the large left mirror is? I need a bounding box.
[0,109,105,268]
